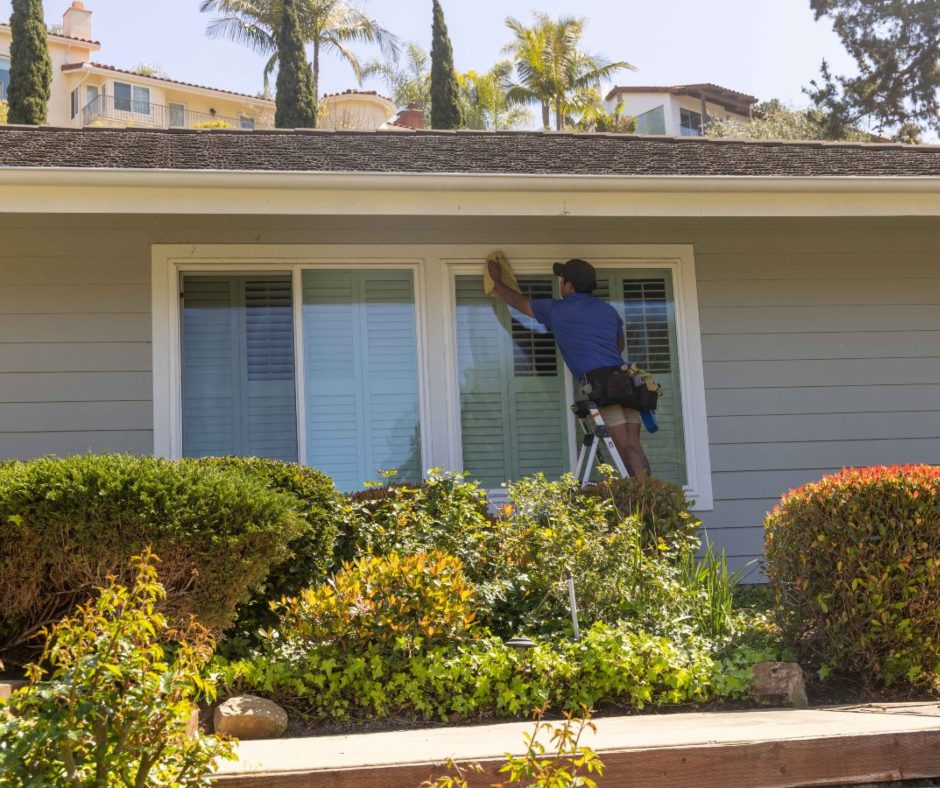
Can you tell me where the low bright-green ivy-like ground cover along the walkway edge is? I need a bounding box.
[216,623,777,721]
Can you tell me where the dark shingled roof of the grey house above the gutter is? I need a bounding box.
[0,126,940,177]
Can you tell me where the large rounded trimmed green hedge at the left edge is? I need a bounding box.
[0,455,301,660]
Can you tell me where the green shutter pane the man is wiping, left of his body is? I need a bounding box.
[456,276,568,488]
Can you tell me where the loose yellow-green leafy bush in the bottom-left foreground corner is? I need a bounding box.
[0,553,231,786]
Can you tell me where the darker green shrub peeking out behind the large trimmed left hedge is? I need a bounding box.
[199,457,340,645]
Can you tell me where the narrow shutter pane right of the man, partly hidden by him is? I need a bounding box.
[595,269,686,484]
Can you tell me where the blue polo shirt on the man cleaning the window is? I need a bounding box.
[531,293,623,378]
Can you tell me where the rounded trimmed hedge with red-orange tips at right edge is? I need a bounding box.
[766,465,940,686]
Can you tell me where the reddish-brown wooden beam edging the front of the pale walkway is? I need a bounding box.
[216,731,940,788]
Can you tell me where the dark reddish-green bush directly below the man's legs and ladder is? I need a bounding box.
[585,476,701,550]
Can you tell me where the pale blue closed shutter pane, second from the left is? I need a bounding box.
[303,270,422,490]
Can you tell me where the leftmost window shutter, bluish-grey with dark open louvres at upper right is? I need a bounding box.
[182,275,297,461]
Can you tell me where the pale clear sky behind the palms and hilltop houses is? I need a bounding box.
[0,0,854,114]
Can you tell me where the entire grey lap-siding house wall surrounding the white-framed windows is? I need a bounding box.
[0,214,940,564]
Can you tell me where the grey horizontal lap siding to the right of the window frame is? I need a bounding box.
[696,228,940,571]
